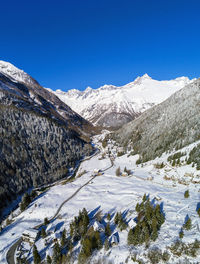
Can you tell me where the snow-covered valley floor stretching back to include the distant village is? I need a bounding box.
[0,135,200,264]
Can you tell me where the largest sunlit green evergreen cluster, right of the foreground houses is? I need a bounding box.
[128,195,165,245]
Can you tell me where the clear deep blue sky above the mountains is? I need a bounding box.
[0,0,200,90]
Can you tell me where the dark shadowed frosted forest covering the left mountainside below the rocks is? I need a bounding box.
[0,99,91,217]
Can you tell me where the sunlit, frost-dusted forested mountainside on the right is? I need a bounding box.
[113,79,200,161]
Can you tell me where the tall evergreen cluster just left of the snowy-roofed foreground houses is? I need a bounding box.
[70,208,90,241]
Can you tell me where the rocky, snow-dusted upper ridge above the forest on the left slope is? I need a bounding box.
[0,61,93,135]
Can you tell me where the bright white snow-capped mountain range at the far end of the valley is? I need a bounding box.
[49,74,195,128]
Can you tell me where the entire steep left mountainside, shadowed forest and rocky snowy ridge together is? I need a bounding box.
[0,62,93,217]
